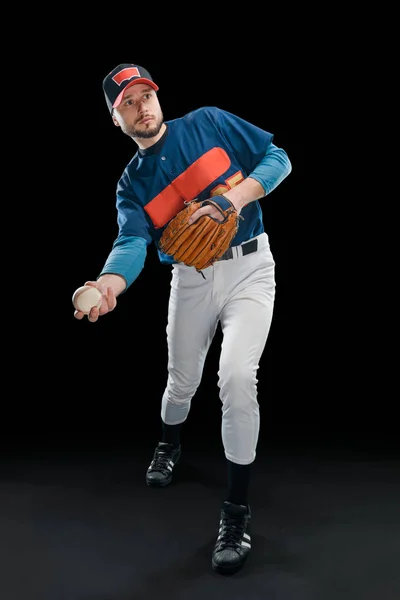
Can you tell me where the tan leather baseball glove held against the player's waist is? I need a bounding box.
[159,195,243,271]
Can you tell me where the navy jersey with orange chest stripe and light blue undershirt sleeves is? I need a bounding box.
[101,107,291,285]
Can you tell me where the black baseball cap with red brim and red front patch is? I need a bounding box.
[103,63,158,112]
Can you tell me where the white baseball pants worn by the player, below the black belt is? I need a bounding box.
[161,233,275,465]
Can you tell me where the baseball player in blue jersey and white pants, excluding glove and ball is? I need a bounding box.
[74,63,292,574]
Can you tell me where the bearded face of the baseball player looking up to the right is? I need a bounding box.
[112,83,163,141]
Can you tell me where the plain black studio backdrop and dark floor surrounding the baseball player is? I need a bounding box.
[0,16,400,600]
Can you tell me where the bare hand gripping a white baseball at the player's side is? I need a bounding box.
[72,281,117,323]
